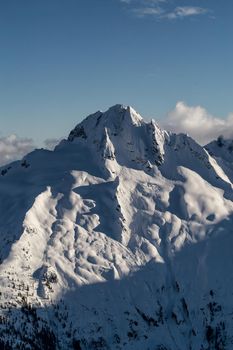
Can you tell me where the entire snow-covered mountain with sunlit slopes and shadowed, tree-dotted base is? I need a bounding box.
[0,105,233,350]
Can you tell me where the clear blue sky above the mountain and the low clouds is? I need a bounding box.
[0,0,233,155]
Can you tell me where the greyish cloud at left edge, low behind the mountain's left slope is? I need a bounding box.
[0,134,35,165]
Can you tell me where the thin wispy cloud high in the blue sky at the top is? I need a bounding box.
[120,0,210,20]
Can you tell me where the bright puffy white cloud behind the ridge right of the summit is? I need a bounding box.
[160,102,233,145]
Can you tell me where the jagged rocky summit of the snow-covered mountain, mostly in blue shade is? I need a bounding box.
[65,104,168,174]
